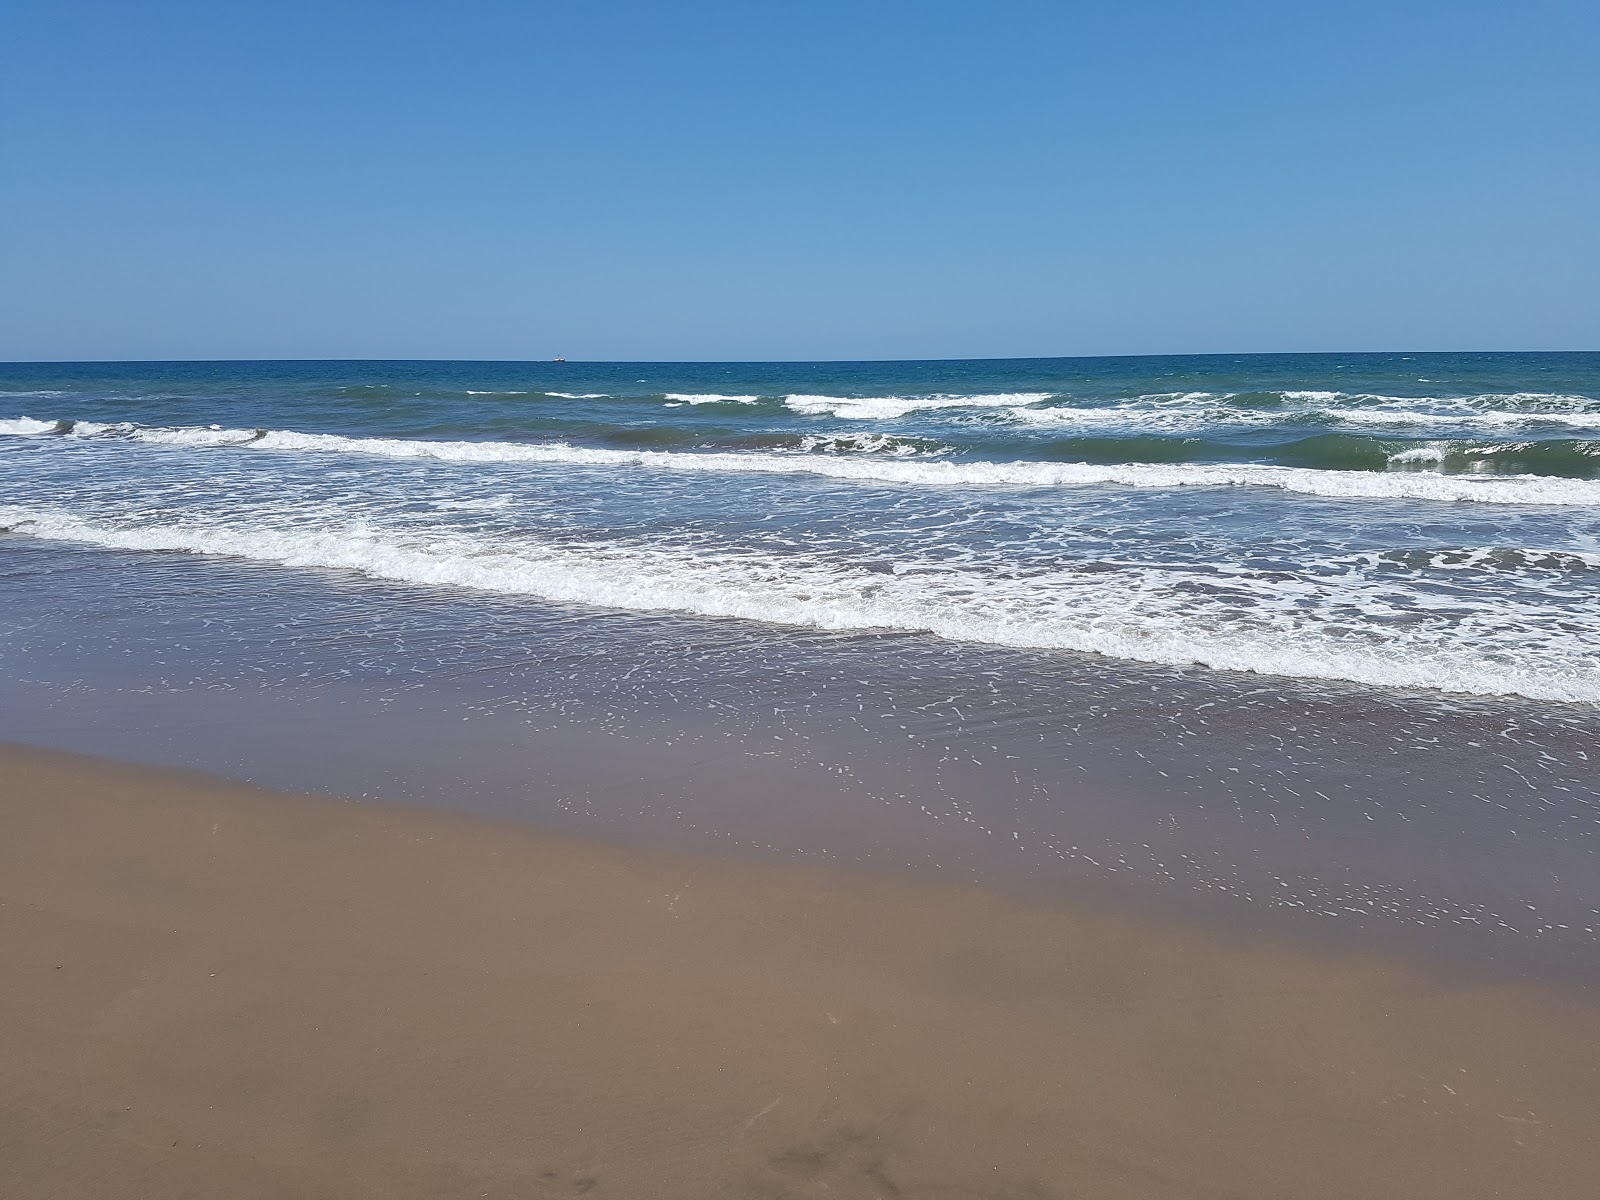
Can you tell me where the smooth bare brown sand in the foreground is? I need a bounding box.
[0,747,1600,1200]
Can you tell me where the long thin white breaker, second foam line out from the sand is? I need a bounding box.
[12,421,1600,507]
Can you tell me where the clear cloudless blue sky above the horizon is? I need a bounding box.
[0,0,1600,360]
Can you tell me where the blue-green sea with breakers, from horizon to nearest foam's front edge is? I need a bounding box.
[0,354,1600,704]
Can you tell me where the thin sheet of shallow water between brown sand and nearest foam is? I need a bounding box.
[0,541,1600,979]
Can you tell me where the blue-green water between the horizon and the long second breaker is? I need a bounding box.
[0,354,1600,478]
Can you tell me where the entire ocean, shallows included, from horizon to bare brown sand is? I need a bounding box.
[0,354,1600,979]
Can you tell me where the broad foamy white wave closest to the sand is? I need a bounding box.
[0,507,1600,702]
